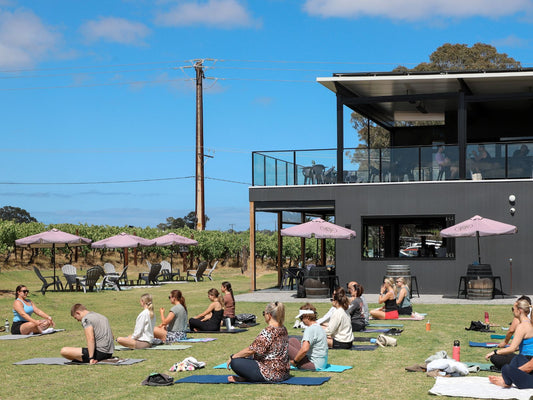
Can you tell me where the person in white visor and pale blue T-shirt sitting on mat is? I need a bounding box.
[289,303,328,370]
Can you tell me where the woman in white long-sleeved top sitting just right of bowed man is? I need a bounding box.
[117,293,155,349]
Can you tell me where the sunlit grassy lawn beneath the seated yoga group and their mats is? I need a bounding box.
[0,268,512,400]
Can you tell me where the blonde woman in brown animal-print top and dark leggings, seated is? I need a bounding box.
[227,301,290,382]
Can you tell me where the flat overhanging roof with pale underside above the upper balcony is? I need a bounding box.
[317,69,533,126]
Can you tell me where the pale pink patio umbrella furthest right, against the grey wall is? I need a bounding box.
[440,215,518,264]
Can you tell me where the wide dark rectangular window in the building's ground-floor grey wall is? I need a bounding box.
[361,215,455,260]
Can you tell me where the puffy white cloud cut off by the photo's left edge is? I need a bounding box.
[0,10,61,68]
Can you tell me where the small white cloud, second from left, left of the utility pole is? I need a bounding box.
[80,17,150,46]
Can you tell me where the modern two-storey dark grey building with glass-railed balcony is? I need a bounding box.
[249,69,533,294]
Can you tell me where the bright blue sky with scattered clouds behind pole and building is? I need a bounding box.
[0,0,533,230]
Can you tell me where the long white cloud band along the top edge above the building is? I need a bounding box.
[304,0,533,21]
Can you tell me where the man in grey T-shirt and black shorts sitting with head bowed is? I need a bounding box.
[61,304,115,364]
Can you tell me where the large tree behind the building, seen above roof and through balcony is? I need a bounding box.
[346,43,522,150]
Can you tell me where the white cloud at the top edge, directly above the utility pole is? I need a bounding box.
[155,0,259,28]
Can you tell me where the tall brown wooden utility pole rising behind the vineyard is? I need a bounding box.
[194,60,205,231]
